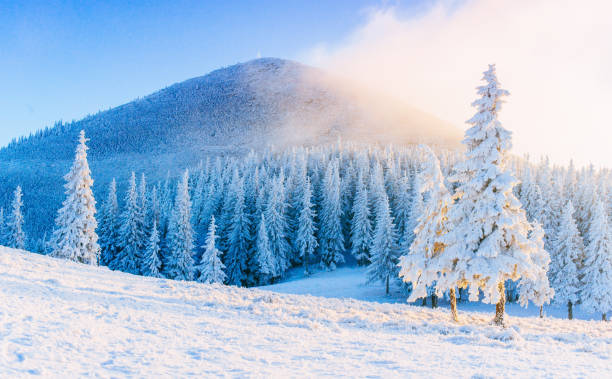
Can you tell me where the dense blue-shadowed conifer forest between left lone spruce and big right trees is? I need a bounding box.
[98,144,440,287]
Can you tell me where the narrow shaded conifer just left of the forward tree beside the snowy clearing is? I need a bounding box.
[351,170,372,266]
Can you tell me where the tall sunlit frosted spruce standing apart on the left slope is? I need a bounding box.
[51,130,100,265]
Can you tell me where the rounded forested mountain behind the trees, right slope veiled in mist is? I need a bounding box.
[0,58,460,245]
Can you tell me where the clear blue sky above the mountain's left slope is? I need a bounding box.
[0,0,414,145]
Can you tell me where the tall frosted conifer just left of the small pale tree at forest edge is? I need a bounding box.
[164,170,193,280]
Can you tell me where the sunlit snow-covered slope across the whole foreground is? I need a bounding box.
[0,248,612,378]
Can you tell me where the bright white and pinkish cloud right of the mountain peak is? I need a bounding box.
[305,0,612,166]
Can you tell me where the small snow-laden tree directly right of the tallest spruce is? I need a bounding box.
[518,221,555,318]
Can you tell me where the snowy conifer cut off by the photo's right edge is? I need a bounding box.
[581,200,612,321]
